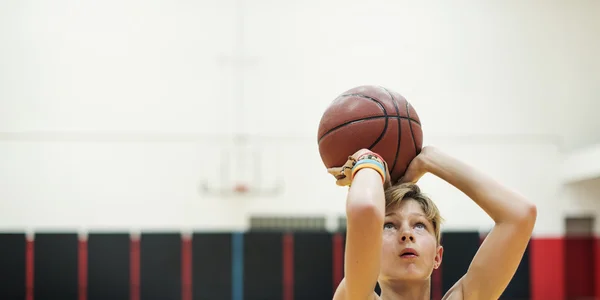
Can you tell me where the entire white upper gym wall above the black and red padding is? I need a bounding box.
[0,0,600,234]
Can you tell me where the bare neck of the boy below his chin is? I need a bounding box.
[380,280,431,300]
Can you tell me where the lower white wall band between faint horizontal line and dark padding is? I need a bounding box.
[0,138,560,230]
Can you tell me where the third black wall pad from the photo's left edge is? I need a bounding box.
[88,233,131,300]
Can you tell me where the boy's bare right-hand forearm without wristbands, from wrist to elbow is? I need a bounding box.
[426,149,535,223]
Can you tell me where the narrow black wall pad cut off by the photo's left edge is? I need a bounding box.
[0,233,26,299]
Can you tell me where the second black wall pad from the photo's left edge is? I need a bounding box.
[34,233,79,300]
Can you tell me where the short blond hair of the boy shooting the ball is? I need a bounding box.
[385,183,443,245]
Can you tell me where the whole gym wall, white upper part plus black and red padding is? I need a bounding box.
[0,0,600,300]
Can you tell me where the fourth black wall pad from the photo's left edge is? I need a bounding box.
[140,233,182,300]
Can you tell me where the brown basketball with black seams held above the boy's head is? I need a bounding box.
[318,85,423,183]
